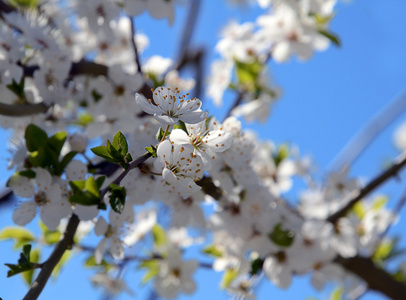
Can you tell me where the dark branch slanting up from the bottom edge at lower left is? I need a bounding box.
[23,214,80,300]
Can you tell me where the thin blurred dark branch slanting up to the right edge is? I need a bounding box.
[327,153,406,223]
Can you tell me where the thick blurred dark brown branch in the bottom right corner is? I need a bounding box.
[334,256,406,300]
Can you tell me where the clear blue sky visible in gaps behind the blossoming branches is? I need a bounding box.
[0,0,406,300]
